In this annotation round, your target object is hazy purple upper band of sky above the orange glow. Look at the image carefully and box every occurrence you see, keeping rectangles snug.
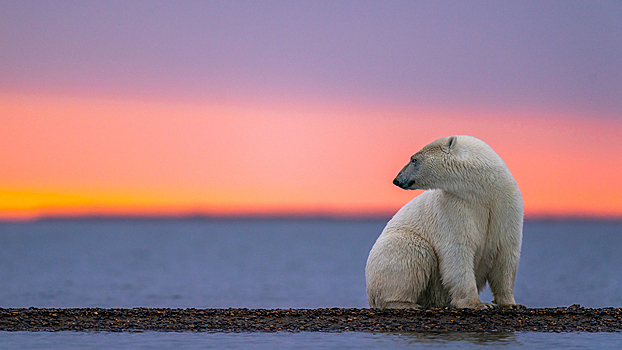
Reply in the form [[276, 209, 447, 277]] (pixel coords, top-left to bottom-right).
[[0, 0, 622, 118]]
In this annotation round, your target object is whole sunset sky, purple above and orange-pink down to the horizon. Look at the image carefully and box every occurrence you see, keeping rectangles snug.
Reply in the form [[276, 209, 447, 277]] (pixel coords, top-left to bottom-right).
[[0, 0, 622, 219]]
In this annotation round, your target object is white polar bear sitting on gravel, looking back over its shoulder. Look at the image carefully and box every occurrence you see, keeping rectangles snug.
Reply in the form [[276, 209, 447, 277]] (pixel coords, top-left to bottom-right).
[[365, 135, 524, 309]]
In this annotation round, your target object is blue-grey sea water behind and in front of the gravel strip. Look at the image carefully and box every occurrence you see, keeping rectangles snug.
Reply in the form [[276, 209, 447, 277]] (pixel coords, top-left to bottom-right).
[[0, 217, 622, 349]]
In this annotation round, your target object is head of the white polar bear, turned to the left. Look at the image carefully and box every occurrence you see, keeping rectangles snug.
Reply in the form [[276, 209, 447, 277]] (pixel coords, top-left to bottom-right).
[[393, 135, 504, 192]]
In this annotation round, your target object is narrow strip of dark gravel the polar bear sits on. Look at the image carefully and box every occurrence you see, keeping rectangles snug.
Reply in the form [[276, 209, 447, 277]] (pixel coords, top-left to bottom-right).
[[0, 305, 622, 333]]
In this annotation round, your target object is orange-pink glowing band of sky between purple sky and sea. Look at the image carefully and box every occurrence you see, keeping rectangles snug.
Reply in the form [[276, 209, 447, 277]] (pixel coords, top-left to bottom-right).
[[0, 93, 622, 219]]
